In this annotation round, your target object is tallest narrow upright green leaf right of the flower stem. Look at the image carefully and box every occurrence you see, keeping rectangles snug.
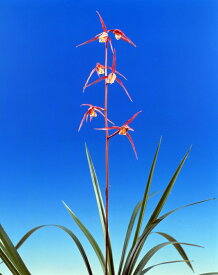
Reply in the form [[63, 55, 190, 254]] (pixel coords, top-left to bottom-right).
[[132, 138, 162, 246]]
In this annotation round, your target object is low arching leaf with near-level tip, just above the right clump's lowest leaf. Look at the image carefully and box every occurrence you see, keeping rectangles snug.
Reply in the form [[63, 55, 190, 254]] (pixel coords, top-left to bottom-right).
[[133, 242, 201, 275]]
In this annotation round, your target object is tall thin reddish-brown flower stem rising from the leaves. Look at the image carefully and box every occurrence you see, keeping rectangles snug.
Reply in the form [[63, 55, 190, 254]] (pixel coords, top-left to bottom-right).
[[104, 43, 109, 275]]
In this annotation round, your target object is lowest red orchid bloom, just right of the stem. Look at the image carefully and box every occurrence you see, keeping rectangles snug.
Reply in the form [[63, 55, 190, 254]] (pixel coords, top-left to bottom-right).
[[96, 111, 142, 159]]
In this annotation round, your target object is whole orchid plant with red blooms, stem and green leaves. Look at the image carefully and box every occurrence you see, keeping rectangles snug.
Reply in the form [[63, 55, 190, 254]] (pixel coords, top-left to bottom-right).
[[0, 11, 218, 275]]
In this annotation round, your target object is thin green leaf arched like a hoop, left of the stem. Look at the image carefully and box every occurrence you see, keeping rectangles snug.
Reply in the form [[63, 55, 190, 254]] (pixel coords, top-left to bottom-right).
[[5, 224, 93, 275]]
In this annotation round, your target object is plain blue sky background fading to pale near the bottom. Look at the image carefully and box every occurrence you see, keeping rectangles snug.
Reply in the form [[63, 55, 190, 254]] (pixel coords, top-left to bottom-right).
[[0, 0, 218, 275]]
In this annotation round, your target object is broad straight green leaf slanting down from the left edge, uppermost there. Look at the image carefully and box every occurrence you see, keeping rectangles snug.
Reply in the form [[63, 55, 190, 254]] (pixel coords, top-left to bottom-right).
[[0, 225, 30, 275]]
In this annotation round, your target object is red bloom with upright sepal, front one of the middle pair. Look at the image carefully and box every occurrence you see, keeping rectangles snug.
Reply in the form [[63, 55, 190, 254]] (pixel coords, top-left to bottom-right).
[[83, 50, 132, 101]]
